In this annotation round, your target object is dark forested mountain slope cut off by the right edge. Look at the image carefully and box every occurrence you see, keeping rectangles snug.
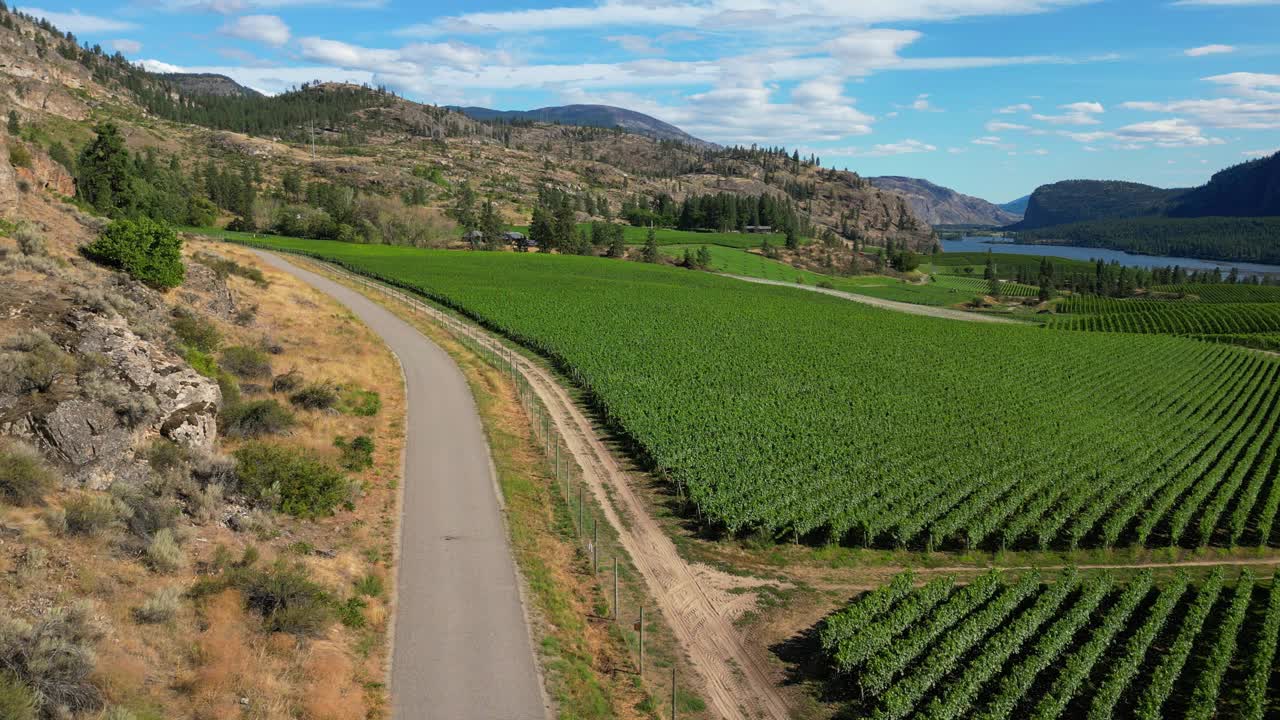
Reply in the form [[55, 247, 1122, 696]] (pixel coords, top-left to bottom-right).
[[1169, 152, 1280, 218]]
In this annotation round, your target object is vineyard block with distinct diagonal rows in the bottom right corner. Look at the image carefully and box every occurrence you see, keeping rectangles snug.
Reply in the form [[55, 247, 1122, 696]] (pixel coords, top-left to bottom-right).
[[819, 568, 1280, 720]]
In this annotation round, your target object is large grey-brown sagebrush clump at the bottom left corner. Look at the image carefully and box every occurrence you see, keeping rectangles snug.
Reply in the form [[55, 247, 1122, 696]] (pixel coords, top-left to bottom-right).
[[0, 603, 102, 717]]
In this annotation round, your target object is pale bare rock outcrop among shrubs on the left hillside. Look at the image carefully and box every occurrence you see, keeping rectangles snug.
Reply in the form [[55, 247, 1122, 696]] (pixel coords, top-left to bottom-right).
[[73, 314, 223, 450]]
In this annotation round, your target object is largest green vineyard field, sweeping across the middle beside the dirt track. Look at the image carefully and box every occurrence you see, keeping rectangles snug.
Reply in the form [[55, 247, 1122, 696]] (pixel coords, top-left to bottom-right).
[[227, 233, 1280, 547]]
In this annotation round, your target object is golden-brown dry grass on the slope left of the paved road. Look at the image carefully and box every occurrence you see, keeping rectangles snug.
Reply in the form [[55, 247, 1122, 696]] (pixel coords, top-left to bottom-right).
[[0, 239, 404, 720]]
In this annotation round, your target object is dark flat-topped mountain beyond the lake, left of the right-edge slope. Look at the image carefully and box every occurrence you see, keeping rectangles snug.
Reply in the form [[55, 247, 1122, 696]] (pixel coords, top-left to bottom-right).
[[1014, 181, 1188, 231]]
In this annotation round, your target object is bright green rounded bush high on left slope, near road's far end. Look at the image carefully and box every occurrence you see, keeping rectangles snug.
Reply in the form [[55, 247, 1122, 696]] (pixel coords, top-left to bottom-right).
[[84, 218, 187, 290]]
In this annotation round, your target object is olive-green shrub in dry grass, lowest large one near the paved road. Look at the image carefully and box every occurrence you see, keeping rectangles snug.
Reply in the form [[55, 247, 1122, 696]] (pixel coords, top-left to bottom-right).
[[238, 561, 333, 635]]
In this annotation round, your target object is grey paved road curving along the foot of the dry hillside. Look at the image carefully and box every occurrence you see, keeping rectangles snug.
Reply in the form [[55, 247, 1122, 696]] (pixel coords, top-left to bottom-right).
[[259, 252, 550, 720]]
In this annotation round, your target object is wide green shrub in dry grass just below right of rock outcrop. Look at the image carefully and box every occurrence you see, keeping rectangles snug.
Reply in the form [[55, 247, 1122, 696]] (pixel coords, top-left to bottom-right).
[[236, 442, 351, 518]]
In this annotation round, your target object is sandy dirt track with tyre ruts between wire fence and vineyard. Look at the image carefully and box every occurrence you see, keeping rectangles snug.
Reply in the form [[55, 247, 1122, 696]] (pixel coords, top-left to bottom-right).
[[290, 257, 791, 720]]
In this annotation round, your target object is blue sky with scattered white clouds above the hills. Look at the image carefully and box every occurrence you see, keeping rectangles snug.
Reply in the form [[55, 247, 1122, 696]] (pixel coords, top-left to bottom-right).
[[19, 0, 1280, 201]]
